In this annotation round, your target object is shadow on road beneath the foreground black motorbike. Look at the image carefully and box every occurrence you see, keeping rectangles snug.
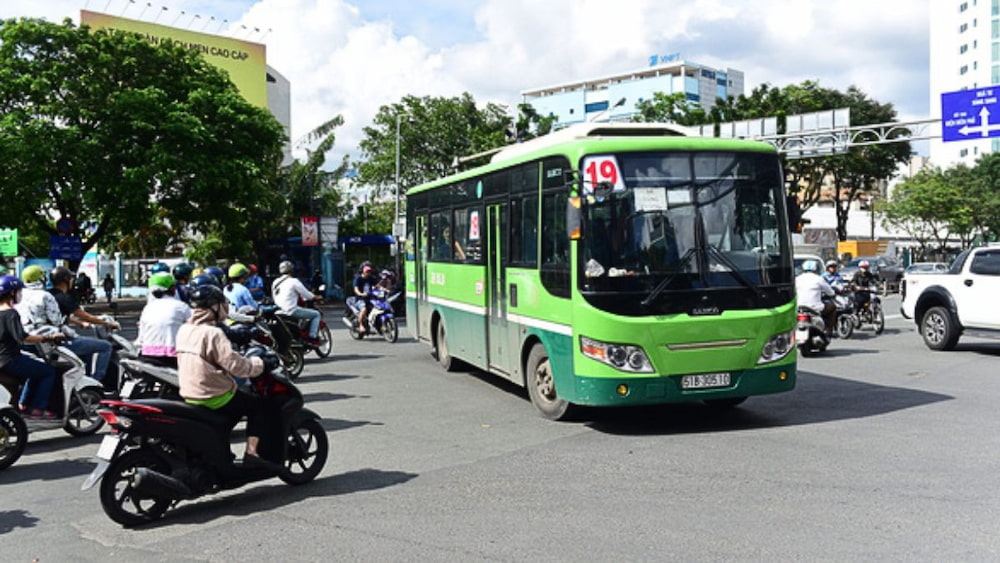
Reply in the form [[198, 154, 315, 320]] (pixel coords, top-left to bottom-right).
[[136, 468, 418, 530]]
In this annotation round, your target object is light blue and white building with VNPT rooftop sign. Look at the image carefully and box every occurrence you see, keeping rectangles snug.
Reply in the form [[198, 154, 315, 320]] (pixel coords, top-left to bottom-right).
[[521, 54, 743, 127]]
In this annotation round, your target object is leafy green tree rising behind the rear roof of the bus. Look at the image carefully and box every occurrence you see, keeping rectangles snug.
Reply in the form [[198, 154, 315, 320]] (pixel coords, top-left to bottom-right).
[[358, 92, 511, 203]]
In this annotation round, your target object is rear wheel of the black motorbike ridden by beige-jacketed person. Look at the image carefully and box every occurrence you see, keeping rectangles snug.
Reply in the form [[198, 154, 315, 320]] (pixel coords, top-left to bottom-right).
[[100, 450, 171, 527]]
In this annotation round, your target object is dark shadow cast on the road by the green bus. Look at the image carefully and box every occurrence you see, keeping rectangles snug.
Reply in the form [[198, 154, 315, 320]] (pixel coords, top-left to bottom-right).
[[584, 371, 954, 435]]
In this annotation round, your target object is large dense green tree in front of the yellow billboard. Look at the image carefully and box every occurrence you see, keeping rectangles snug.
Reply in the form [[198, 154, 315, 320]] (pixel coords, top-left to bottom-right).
[[0, 15, 283, 266]]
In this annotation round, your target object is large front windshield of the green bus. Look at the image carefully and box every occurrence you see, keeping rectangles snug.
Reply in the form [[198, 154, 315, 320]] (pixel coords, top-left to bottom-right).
[[579, 151, 793, 308]]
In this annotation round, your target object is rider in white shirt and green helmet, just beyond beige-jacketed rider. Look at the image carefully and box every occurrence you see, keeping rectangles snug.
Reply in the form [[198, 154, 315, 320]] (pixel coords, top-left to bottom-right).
[[136, 272, 191, 368]]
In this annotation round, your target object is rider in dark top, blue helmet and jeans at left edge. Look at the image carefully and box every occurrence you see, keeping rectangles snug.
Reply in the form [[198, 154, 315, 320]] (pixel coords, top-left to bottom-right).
[[0, 275, 62, 419]]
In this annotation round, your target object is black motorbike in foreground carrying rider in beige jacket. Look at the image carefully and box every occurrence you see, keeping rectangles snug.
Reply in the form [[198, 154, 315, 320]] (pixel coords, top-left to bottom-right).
[[82, 352, 329, 527]]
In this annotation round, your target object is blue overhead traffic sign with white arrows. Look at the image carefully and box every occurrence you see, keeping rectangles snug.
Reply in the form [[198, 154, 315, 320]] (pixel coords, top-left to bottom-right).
[[941, 86, 1000, 142]]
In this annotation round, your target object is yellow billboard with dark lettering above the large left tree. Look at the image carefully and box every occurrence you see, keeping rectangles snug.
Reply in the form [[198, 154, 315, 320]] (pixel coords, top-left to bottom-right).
[[80, 10, 267, 109]]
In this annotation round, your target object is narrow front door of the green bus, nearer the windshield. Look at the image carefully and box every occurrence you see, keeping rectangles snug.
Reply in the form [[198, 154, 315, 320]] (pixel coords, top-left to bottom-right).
[[486, 202, 510, 374]]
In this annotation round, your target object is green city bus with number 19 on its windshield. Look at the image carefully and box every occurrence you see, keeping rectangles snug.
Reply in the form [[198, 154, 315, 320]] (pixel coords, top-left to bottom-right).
[[406, 123, 796, 419]]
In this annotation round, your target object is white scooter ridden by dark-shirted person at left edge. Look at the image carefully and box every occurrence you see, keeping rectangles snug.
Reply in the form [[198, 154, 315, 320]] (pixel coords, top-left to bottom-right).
[[0, 326, 104, 436]]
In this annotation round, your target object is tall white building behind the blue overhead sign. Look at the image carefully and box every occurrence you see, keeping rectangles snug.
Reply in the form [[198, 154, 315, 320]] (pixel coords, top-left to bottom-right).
[[930, 0, 1000, 168]]
